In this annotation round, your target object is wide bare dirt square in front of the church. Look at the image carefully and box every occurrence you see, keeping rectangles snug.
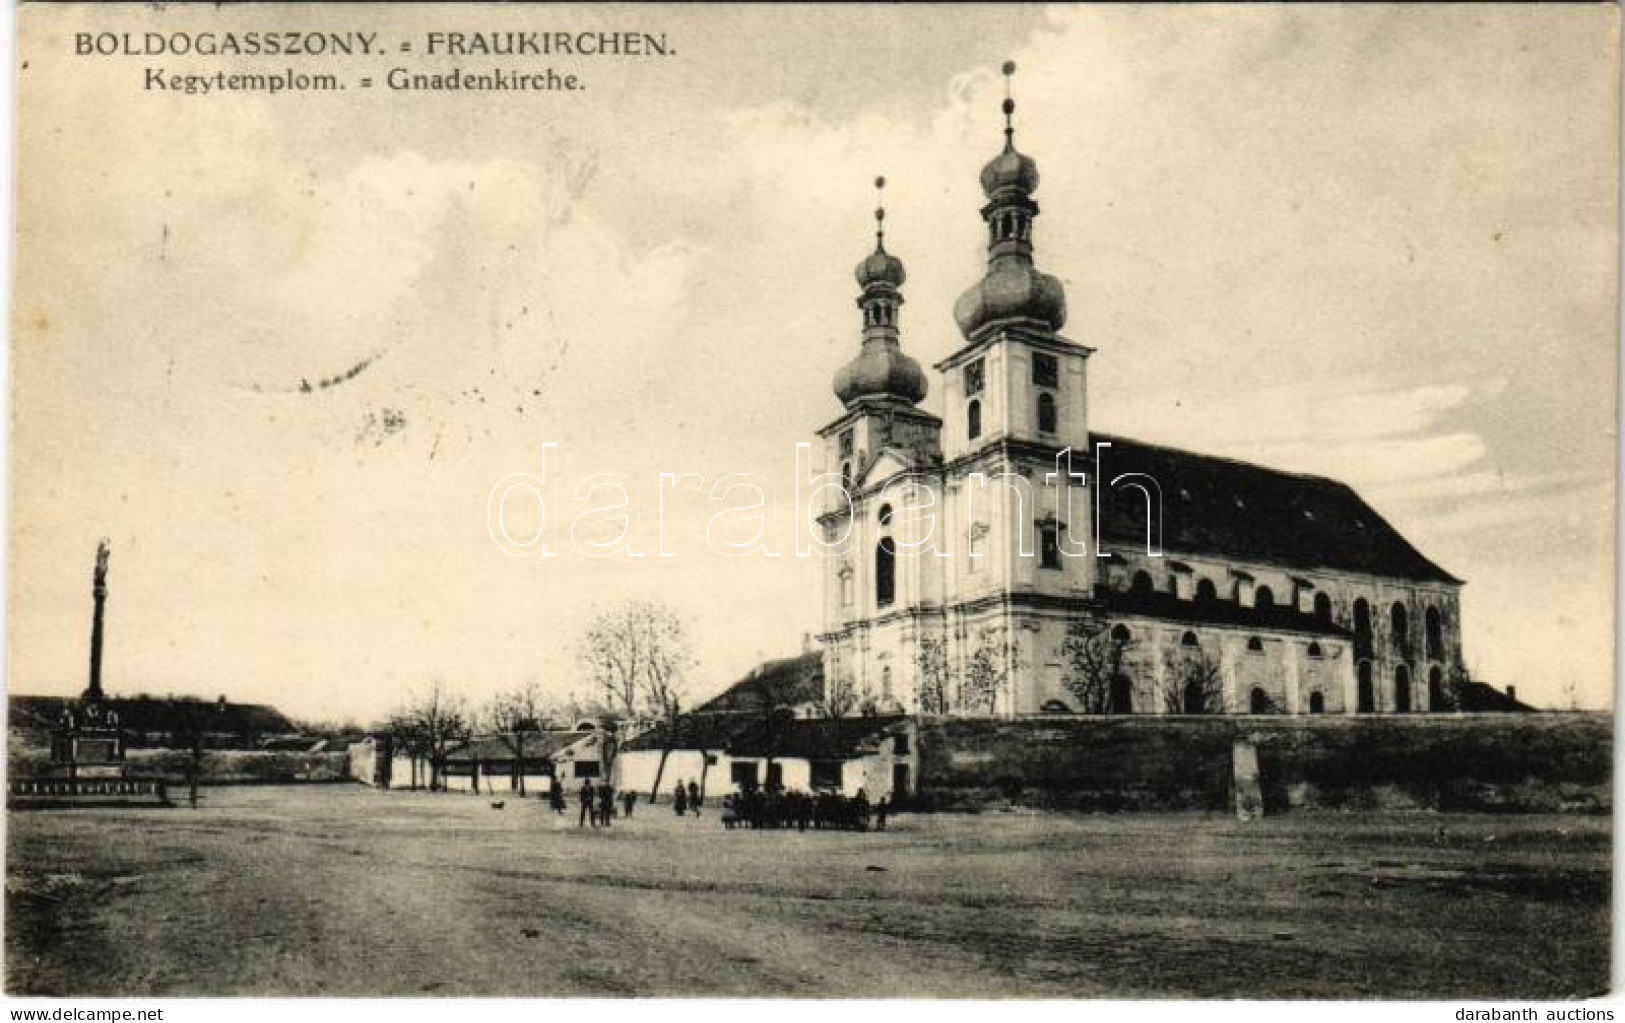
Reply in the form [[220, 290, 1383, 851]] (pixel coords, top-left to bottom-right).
[[5, 786, 1610, 999]]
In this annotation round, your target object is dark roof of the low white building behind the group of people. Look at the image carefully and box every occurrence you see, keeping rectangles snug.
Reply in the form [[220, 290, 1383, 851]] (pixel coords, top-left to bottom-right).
[[622, 714, 904, 760]]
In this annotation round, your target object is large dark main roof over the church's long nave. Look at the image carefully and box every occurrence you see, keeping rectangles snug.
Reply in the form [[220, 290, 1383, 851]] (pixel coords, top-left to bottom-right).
[[1094, 434, 1459, 583]]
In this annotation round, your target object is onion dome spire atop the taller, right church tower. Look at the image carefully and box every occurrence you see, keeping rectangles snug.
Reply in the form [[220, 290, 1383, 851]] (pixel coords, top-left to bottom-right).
[[954, 62, 1066, 341]]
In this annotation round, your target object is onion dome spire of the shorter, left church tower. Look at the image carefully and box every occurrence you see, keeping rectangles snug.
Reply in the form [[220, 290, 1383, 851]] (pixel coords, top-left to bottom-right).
[[834, 177, 926, 409]]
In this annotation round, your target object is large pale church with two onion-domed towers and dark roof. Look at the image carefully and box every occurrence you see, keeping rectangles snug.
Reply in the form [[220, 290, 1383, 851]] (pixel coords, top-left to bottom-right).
[[819, 80, 1464, 714]]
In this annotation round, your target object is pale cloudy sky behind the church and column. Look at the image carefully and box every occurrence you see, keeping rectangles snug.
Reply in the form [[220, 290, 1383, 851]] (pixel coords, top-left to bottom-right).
[[10, 5, 1619, 721]]
